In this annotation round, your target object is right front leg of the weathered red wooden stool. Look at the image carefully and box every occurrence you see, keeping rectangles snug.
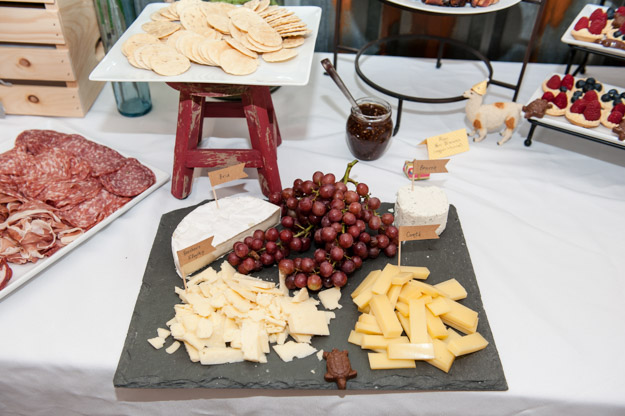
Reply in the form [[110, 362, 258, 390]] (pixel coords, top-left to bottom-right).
[[241, 86, 282, 195]]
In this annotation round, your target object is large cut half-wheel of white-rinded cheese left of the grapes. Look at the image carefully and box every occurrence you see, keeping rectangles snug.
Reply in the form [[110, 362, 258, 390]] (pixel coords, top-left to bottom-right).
[[171, 196, 280, 276]]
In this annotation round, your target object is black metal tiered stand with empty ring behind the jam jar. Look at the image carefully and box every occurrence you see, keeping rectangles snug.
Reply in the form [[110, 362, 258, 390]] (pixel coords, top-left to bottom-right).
[[334, 0, 546, 135]]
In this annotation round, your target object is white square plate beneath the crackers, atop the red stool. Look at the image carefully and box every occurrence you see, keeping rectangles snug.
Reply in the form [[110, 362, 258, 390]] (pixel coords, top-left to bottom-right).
[[89, 3, 321, 86]]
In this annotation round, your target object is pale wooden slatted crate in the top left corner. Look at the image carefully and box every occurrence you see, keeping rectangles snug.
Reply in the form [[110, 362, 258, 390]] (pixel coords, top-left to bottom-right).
[[0, 0, 104, 117]]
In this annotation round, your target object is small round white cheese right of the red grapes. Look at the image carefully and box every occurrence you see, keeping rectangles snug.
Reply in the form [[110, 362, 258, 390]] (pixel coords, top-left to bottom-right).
[[395, 185, 449, 235]]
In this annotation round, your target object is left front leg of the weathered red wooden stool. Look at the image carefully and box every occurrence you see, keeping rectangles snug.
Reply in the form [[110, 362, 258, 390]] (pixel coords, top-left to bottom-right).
[[171, 91, 204, 199]]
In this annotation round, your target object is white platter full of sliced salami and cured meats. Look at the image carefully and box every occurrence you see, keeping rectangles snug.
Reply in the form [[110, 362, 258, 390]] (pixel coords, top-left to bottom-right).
[[0, 130, 169, 299]]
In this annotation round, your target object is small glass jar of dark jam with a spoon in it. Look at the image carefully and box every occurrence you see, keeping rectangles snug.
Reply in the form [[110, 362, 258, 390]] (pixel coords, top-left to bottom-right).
[[346, 97, 393, 160]]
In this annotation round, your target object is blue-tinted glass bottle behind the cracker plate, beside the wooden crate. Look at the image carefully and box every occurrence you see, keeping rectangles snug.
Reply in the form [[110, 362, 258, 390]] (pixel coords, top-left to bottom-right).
[[93, 0, 152, 117]]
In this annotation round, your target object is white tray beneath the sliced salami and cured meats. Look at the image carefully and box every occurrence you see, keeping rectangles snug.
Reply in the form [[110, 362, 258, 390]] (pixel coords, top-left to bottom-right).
[[0, 137, 169, 300]]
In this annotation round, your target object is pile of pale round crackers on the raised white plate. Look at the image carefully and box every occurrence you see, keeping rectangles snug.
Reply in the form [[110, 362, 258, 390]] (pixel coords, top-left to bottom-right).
[[122, 0, 311, 76]]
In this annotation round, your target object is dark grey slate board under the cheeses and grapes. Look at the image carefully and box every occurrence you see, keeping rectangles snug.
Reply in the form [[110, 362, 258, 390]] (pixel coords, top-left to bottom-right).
[[113, 203, 508, 391]]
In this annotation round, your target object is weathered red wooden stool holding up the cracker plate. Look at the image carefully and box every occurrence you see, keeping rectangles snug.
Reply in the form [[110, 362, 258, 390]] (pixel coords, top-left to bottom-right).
[[167, 82, 282, 199]]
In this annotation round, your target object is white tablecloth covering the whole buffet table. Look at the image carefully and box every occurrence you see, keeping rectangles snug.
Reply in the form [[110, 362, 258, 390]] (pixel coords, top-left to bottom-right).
[[0, 54, 625, 415]]
